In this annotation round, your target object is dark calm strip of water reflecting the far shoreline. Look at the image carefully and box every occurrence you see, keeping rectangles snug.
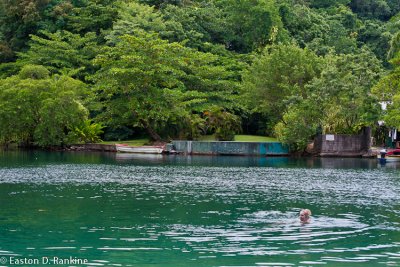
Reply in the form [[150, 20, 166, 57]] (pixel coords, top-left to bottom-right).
[[0, 150, 384, 169]]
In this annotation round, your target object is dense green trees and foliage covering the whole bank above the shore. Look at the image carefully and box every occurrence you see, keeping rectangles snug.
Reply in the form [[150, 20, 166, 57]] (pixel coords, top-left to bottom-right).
[[0, 0, 400, 150]]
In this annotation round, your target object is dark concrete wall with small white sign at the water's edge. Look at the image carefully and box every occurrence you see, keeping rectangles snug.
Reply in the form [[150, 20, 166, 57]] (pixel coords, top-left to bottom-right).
[[314, 128, 371, 157]]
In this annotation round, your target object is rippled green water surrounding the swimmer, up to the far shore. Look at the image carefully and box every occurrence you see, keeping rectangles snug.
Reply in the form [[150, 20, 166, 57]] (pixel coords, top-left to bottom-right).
[[0, 151, 400, 267]]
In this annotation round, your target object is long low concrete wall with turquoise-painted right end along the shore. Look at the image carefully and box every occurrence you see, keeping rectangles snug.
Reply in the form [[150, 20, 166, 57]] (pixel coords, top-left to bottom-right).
[[172, 141, 289, 156]]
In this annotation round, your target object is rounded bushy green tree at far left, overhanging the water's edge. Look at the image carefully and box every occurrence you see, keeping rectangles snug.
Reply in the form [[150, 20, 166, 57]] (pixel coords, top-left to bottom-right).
[[0, 65, 97, 147]]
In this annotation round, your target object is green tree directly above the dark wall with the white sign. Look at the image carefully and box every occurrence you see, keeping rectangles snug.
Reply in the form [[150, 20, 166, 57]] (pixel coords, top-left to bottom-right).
[[309, 49, 383, 134]]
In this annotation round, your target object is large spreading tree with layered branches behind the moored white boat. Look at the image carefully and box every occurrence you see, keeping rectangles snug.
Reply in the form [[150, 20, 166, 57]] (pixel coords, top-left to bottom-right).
[[94, 32, 242, 140]]
